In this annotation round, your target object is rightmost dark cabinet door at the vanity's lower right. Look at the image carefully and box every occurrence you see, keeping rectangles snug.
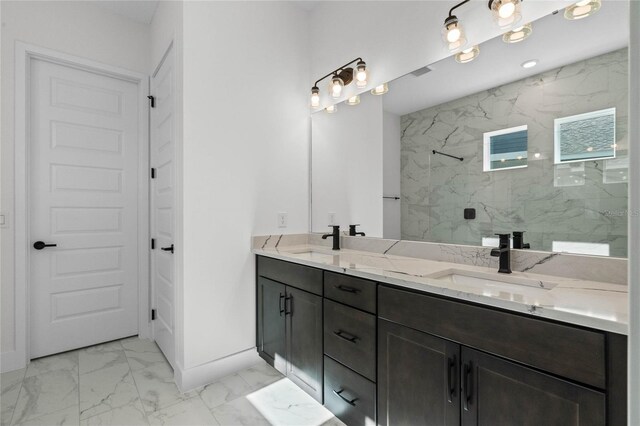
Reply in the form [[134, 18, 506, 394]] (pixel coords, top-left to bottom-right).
[[460, 347, 606, 426]]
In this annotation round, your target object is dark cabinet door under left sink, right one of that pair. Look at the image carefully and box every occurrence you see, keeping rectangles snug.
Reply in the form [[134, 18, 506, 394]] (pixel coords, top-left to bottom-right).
[[286, 287, 323, 403]]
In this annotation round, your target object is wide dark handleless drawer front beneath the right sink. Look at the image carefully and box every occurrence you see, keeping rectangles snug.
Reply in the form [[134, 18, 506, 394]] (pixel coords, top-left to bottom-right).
[[378, 286, 606, 389]]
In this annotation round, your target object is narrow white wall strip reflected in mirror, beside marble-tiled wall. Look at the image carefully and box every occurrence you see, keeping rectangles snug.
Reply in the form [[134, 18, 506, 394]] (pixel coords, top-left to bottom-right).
[[382, 111, 402, 240]]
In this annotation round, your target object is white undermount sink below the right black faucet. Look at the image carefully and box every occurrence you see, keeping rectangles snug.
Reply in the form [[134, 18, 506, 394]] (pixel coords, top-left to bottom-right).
[[429, 269, 558, 290]]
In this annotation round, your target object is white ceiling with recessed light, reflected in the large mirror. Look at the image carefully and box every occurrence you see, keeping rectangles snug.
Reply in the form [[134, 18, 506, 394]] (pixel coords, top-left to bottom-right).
[[384, 1, 629, 115]]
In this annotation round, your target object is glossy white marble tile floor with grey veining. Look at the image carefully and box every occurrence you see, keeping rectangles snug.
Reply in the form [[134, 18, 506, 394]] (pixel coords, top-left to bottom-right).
[[0, 337, 343, 426]]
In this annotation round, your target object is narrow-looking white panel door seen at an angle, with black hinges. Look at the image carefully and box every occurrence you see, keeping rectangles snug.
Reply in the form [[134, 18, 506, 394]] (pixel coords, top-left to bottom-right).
[[151, 45, 175, 366]]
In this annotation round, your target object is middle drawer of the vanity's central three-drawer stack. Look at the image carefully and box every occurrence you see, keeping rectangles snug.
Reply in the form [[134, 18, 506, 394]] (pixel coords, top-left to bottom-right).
[[324, 299, 376, 381]]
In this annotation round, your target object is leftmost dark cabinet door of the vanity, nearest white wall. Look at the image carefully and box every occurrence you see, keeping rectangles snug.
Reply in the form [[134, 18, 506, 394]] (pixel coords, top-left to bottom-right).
[[257, 277, 286, 374]]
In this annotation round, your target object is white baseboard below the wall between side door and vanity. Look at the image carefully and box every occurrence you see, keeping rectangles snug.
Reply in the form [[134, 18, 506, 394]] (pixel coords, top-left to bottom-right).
[[174, 348, 261, 392]]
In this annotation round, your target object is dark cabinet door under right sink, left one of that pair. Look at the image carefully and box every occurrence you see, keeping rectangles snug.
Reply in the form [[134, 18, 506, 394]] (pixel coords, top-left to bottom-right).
[[378, 320, 460, 426]]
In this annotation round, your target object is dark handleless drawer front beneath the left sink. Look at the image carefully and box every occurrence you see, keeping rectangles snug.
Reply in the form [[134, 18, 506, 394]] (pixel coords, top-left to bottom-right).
[[258, 256, 322, 296]]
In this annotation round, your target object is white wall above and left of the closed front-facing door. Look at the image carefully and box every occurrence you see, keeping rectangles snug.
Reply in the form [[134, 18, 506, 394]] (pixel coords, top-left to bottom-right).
[[0, 1, 149, 370]]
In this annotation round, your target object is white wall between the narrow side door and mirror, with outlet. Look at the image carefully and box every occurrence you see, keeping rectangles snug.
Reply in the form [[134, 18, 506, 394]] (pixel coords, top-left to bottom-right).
[[182, 2, 311, 376]]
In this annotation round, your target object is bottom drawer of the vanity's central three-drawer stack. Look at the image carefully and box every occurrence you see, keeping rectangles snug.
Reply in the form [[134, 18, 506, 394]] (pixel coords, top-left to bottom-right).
[[324, 356, 376, 426]]
